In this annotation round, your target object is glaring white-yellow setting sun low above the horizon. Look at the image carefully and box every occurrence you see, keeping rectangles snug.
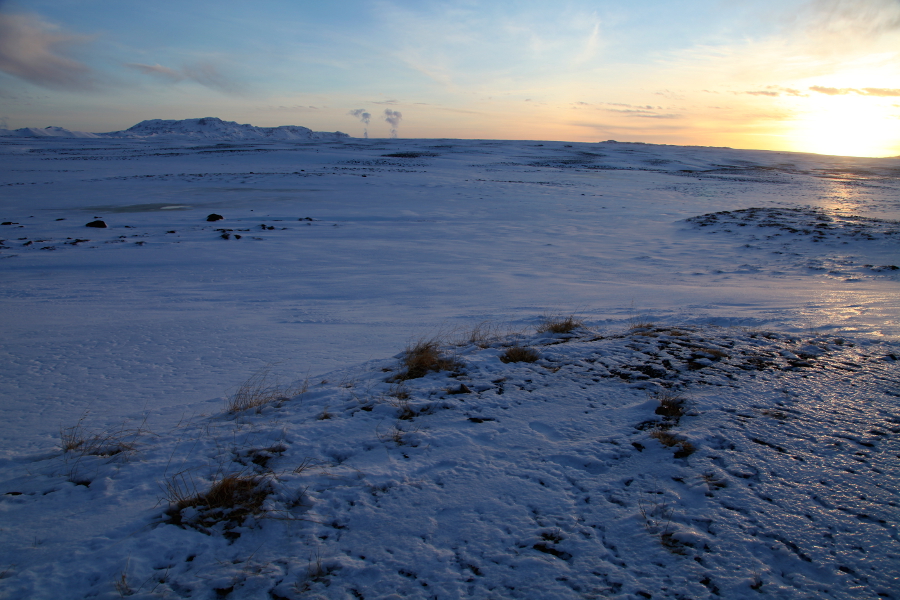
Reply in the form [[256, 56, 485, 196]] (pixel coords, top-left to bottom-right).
[[787, 94, 900, 157]]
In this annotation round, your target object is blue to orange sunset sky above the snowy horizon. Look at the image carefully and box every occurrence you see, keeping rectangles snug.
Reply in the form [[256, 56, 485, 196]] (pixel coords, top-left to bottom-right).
[[0, 0, 900, 156]]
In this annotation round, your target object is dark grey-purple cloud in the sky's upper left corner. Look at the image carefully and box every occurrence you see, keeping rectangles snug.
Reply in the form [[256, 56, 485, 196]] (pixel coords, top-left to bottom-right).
[[0, 14, 97, 91]]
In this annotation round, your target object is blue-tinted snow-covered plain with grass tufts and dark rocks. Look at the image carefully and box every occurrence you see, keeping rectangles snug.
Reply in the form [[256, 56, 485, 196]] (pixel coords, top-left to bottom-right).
[[0, 134, 900, 599]]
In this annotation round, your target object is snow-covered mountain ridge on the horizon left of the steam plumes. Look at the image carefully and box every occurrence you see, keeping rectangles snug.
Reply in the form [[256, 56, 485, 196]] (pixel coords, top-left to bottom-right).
[[0, 117, 350, 141]]
